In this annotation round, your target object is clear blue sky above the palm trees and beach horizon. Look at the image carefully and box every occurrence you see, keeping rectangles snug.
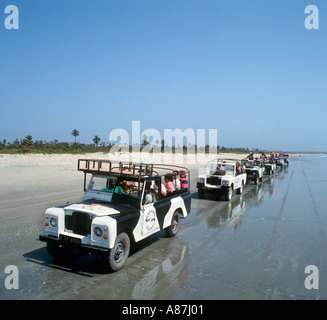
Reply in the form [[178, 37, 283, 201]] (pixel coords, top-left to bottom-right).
[[0, 0, 327, 151]]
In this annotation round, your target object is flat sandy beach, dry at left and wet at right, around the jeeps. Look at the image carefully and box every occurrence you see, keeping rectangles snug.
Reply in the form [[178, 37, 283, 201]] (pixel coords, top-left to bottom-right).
[[0, 155, 327, 300]]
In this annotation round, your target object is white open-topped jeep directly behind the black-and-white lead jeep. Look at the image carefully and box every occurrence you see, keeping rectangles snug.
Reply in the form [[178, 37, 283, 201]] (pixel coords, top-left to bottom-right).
[[197, 160, 246, 201]]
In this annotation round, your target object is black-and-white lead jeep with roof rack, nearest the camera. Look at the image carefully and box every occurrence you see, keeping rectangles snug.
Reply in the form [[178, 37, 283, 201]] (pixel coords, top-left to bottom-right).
[[39, 159, 191, 272]]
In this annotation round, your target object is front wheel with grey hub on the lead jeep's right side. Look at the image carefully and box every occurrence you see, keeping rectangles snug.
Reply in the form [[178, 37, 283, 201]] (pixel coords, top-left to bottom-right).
[[104, 232, 131, 272]]
